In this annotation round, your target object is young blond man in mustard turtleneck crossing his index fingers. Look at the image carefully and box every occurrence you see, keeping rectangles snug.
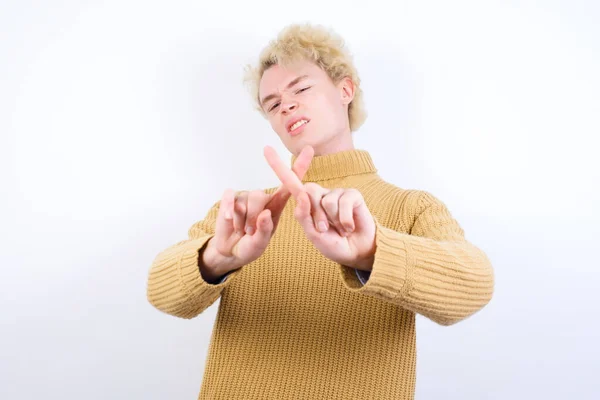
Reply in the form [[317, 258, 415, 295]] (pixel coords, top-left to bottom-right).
[[147, 25, 494, 399]]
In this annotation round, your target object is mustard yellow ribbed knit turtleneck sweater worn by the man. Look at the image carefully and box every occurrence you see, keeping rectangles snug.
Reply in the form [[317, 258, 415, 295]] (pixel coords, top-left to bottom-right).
[[147, 150, 494, 400]]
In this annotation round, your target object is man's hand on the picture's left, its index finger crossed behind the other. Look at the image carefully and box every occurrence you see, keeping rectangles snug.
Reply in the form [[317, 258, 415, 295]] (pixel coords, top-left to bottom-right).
[[199, 146, 314, 280]]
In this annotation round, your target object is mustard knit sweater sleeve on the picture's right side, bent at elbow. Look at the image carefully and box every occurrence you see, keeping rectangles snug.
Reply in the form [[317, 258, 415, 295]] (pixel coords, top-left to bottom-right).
[[340, 192, 494, 325]]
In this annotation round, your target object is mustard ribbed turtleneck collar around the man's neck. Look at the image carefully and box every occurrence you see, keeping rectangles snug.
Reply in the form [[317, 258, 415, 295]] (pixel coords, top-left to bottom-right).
[[290, 149, 377, 182]]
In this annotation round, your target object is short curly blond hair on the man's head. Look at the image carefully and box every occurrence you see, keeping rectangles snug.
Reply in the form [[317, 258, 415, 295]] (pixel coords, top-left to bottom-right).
[[244, 23, 367, 131]]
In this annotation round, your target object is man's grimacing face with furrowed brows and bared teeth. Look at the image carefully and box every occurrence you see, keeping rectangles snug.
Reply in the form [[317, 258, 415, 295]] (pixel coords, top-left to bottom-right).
[[259, 61, 354, 155]]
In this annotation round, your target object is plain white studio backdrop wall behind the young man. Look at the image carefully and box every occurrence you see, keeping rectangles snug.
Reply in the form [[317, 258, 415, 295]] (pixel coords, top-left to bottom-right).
[[0, 0, 600, 400]]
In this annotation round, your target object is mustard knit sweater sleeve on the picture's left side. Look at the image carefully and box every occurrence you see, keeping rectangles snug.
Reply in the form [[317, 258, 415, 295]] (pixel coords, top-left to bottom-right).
[[146, 202, 242, 319]]
